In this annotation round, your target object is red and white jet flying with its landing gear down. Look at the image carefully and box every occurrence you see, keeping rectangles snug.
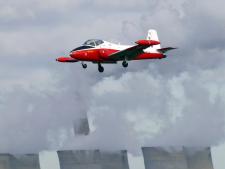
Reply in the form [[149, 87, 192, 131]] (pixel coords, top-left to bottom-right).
[[56, 30, 176, 72]]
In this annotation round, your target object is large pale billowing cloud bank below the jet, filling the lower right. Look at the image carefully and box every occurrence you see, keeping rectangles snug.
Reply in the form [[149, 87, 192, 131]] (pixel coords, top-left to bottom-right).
[[51, 60, 225, 154]]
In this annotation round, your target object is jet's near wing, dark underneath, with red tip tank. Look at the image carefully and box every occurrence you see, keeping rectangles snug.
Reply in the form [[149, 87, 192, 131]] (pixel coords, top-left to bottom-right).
[[109, 40, 160, 61]]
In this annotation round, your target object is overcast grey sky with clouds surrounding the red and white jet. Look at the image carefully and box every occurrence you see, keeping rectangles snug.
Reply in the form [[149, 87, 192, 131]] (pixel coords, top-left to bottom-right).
[[0, 0, 225, 168]]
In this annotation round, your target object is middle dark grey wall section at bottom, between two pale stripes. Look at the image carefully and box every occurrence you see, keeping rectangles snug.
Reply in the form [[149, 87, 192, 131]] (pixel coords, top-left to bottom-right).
[[58, 150, 129, 169]]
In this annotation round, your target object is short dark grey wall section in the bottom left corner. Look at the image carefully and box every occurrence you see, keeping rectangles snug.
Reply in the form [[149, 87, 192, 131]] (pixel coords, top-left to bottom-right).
[[0, 154, 40, 169]]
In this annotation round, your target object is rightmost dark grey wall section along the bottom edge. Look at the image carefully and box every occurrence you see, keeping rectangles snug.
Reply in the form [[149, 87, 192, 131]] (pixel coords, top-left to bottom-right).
[[142, 147, 213, 169]]
